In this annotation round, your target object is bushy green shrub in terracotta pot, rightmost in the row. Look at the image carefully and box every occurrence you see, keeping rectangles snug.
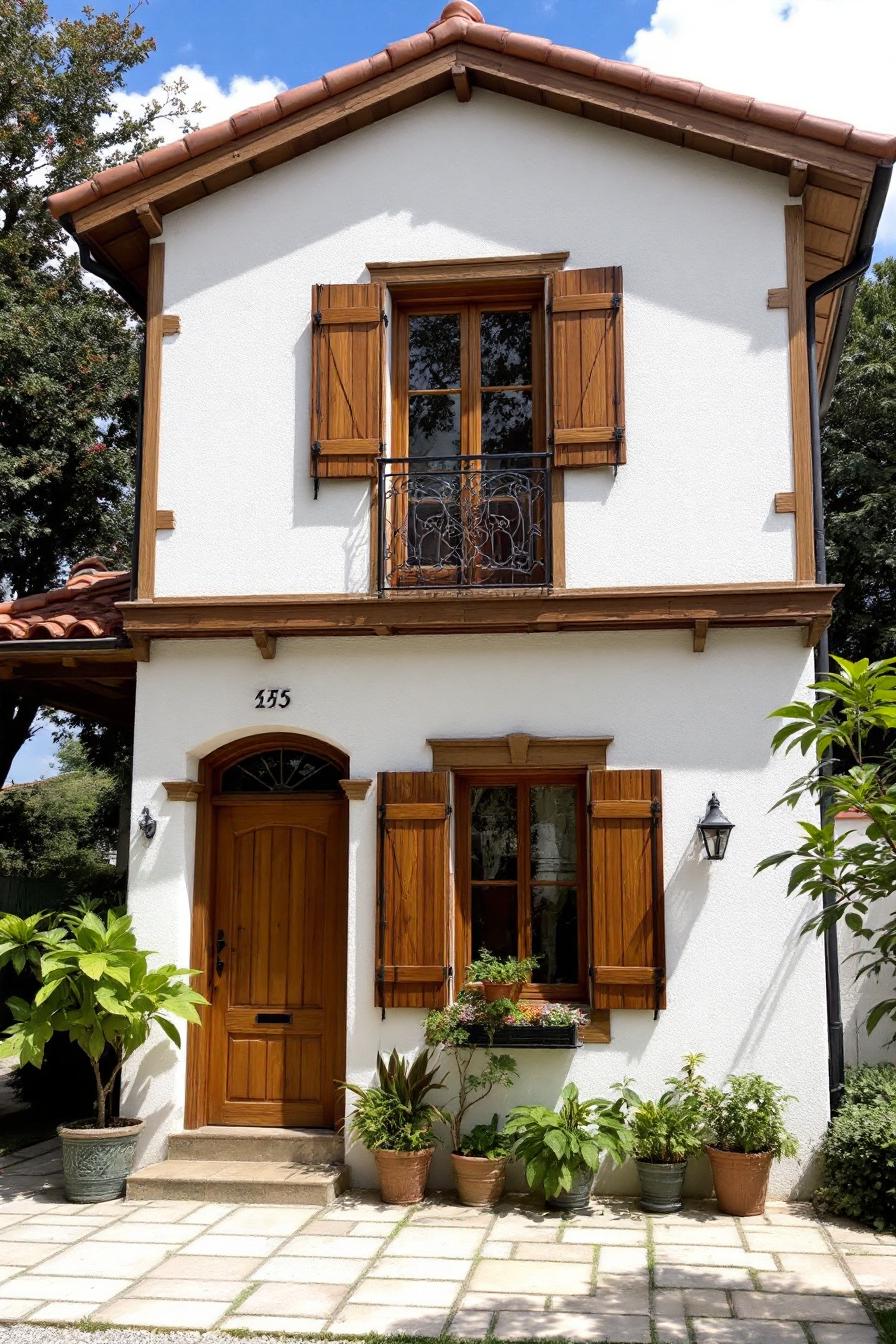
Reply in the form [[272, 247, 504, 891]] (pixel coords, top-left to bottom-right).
[[703, 1074, 797, 1218]]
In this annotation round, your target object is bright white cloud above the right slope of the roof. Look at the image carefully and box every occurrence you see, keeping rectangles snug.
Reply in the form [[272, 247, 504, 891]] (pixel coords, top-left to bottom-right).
[[626, 0, 896, 246]]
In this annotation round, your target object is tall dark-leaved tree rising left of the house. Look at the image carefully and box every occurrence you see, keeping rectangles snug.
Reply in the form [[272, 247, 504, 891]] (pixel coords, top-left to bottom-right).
[[0, 0, 196, 782]]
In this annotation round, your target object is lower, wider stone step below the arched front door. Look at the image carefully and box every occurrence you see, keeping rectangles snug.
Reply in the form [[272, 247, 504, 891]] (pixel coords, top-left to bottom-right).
[[126, 1159, 348, 1206]]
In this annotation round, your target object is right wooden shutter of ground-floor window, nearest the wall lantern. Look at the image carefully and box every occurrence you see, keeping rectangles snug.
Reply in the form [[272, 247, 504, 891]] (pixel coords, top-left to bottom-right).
[[591, 770, 666, 1013]]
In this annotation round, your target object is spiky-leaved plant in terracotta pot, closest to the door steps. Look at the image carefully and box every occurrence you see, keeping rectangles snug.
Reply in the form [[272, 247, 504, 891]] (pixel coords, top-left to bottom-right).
[[343, 1050, 445, 1204]]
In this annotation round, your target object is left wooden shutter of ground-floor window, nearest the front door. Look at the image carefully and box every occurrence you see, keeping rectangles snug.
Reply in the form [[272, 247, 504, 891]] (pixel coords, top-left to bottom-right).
[[376, 770, 450, 1009]]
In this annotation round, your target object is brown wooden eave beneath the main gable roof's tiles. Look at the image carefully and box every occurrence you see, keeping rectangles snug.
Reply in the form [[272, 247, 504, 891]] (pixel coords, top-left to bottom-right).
[[73, 42, 879, 372]]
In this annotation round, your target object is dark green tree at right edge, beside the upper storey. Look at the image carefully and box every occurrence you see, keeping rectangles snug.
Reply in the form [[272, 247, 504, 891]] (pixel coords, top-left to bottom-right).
[[822, 257, 896, 659]]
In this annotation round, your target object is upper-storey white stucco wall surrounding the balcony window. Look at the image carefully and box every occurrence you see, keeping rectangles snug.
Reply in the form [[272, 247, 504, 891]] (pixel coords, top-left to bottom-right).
[[156, 90, 794, 595]]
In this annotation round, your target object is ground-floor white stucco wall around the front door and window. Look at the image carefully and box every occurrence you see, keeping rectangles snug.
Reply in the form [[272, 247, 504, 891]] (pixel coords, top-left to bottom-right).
[[124, 629, 827, 1195]]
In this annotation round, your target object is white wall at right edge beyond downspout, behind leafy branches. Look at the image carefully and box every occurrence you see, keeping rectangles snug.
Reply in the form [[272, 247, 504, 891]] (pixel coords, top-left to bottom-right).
[[836, 816, 896, 1064]]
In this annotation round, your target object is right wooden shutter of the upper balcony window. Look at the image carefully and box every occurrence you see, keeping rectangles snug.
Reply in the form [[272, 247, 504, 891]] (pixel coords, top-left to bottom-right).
[[549, 266, 626, 466]]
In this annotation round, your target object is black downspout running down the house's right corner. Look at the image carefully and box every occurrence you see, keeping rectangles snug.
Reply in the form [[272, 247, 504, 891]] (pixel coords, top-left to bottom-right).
[[806, 165, 892, 1116]]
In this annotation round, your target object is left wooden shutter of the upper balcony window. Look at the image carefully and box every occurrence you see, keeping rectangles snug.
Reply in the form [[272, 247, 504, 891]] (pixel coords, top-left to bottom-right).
[[312, 285, 386, 482]]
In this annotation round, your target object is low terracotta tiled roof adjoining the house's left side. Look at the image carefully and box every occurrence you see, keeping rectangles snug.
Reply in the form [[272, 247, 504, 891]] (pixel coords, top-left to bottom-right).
[[0, 555, 130, 642]]
